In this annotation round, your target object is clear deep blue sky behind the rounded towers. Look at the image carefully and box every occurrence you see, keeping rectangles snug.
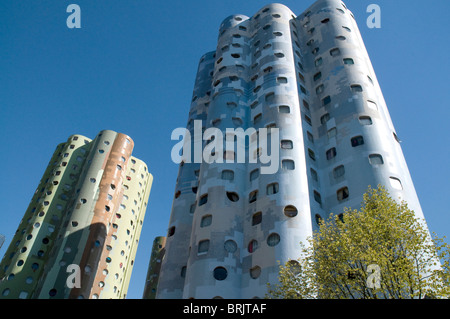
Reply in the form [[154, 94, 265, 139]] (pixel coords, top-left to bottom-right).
[[0, 0, 450, 298]]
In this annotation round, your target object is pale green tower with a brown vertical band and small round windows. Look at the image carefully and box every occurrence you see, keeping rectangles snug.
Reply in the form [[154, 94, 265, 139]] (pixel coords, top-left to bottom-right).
[[0, 130, 153, 299]]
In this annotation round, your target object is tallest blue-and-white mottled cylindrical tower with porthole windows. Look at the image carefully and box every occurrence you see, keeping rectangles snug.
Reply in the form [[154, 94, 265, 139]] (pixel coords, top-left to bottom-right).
[[157, 0, 423, 298]]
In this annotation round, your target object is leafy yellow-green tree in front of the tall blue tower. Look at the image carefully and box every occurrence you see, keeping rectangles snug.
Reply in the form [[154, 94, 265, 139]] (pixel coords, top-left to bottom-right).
[[266, 186, 450, 299]]
